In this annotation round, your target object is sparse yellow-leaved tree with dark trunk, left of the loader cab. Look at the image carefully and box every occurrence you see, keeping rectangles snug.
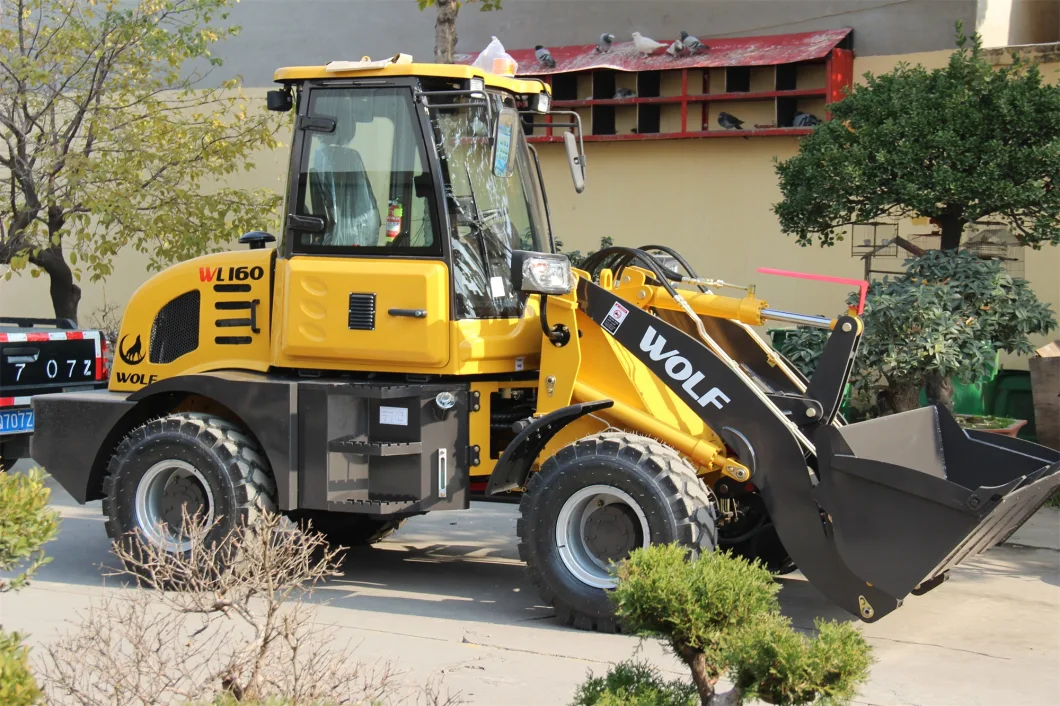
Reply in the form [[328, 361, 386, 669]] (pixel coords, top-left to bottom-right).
[[0, 0, 280, 319]]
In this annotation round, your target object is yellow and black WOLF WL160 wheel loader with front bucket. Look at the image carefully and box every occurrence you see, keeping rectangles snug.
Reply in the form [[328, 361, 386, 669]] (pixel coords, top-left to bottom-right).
[[32, 55, 1060, 631]]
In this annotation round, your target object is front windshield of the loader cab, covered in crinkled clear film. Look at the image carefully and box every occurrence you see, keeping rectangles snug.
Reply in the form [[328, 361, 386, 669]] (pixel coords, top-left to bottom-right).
[[436, 92, 550, 319]]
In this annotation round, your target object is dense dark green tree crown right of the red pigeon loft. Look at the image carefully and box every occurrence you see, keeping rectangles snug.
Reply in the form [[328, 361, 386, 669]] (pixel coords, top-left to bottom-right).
[[774, 23, 1060, 250]]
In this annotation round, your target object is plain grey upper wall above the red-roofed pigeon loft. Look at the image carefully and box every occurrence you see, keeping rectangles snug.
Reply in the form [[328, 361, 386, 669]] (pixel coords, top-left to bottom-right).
[[218, 0, 978, 86]]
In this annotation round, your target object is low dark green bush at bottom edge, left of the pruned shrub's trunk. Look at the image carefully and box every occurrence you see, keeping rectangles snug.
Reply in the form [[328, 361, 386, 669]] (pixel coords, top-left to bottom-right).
[[570, 660, 700, 706]]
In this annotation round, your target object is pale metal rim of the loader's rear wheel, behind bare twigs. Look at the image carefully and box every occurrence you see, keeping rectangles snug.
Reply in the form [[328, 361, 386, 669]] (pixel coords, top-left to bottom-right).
[[136, 459, 214, 552]]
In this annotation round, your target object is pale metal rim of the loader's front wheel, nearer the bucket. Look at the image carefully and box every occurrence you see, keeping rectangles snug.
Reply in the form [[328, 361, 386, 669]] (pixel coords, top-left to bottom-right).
[[555, 486, 651, 588]]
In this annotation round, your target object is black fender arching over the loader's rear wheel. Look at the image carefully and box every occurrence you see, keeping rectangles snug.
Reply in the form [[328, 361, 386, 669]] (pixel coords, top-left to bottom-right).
[[127, 370, 298, 510]]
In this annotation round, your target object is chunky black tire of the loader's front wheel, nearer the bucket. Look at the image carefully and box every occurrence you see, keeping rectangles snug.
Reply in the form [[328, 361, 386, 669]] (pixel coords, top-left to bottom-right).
[[516, 431, 718, 633]]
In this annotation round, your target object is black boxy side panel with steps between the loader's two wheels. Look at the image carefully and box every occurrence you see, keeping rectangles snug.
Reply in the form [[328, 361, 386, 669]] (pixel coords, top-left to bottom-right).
[[298, 382, 470, 515]]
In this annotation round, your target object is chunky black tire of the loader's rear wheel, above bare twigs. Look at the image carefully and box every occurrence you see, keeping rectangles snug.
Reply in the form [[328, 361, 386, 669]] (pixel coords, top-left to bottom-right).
[[103, 412, 277, 540]]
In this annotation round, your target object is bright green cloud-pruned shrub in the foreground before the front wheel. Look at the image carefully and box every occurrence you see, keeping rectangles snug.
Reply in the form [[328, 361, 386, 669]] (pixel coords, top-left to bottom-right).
[[575, 545, 871, 706]]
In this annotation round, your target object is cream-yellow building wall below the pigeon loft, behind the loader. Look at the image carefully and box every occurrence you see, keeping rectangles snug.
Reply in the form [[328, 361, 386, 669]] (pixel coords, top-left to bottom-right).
[[0, 51, 1060, 368]]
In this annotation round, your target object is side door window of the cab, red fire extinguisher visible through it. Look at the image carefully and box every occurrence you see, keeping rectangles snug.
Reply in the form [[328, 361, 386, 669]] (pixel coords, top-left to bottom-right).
[[293, 88, 441, 255]]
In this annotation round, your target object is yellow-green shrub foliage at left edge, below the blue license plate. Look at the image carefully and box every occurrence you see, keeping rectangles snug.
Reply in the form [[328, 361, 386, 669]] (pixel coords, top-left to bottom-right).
[[0, 469, 58, 706]]
